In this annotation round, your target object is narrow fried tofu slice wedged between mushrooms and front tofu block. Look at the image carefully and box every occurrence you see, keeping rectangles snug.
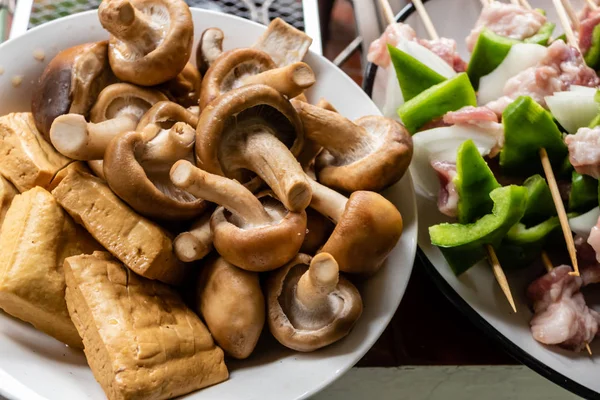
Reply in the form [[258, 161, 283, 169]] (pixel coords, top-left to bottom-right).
[[52, 168, 186, 284]]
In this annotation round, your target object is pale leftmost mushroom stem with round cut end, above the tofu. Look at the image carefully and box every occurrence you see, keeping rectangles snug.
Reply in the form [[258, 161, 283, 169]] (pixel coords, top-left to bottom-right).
[[50, 114, 137, 161]]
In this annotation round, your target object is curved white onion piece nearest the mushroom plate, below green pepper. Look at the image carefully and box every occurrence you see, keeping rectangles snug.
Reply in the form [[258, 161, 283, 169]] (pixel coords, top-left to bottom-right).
[[410, 125, 496, 199]]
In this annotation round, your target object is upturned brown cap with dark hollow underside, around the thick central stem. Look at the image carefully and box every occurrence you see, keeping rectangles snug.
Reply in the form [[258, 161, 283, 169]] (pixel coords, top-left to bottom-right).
[[196, 85, 304, 183]]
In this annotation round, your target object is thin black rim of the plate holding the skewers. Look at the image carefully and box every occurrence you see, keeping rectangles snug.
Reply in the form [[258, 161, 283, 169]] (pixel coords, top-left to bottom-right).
[[362, 0, 600, 399]]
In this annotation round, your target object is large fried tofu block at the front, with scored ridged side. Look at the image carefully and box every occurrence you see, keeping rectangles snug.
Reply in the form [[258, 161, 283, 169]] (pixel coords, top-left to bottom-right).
[[65, 252, 229, 400]]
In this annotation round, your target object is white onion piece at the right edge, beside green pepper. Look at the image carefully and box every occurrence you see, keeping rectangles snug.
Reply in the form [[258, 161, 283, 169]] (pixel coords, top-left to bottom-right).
[[544, 88, 600, 134]]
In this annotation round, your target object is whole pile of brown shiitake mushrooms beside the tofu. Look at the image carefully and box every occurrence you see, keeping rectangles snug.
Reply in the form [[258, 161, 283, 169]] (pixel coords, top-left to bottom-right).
[[23, 0, 412, 359]]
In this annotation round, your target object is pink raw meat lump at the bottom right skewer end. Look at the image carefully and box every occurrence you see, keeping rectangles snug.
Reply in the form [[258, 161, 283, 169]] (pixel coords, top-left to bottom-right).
[[527, 265, 600, 351]]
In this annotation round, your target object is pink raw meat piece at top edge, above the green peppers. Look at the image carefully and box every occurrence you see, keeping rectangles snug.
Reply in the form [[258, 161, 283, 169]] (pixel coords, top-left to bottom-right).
[[467, 1, 546, 51]]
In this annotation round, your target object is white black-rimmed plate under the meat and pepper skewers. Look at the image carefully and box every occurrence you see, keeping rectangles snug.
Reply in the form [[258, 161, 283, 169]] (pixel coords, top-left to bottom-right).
[[365, 0, 600, 398]]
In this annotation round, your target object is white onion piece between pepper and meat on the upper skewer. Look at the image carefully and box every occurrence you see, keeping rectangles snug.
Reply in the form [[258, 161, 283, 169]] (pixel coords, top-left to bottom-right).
[[477, 43, 548, 104]]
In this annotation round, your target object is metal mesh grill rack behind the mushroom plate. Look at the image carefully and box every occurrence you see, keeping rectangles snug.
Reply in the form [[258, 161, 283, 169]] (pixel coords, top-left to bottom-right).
[[29, 0, 305, 30]]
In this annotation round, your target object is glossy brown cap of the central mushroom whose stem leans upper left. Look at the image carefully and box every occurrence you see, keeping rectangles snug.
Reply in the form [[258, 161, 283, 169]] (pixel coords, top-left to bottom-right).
[[210, 192, 306, 272]]
